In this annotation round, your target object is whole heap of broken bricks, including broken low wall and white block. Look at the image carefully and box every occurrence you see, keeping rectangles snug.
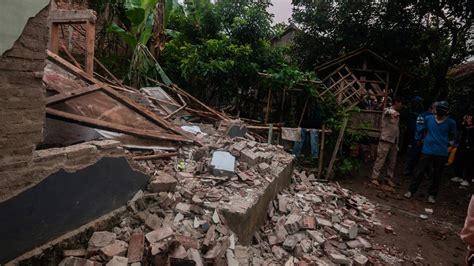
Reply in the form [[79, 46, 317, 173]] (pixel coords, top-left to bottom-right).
[[54, 128, 399, 265]]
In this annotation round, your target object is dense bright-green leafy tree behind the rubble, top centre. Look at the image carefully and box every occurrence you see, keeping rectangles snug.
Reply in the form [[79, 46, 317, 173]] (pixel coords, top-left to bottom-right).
[[160, 0, 306, 116]]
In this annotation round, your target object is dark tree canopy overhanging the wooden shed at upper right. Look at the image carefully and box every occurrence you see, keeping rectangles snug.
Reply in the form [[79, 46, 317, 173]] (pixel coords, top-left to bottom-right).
[[293, 0, 473, 98]]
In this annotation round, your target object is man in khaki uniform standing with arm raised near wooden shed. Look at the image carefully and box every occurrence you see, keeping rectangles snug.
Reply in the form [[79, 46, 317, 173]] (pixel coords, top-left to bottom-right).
[[370, 97, 402, 187]]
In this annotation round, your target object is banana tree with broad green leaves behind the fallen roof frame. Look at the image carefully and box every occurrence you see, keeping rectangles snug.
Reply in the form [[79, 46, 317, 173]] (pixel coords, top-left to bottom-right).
[[108, 0, 171, 86]]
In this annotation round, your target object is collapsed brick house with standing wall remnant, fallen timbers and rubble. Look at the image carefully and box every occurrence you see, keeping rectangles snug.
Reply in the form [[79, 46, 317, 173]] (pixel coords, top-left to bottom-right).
[[0, 3, 414, 265]]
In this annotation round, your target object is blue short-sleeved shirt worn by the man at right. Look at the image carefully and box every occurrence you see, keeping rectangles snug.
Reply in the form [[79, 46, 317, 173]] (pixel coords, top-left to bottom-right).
[[422, 115, 456, 156]]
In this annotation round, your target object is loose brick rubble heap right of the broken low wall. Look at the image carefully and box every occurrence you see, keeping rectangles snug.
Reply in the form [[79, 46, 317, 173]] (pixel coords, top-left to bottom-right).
[[251, 171, 403, 265]]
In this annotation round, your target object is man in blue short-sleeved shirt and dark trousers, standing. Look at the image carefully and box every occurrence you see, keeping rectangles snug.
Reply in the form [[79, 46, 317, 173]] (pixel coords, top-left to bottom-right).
[[404, 101, 456, 203]]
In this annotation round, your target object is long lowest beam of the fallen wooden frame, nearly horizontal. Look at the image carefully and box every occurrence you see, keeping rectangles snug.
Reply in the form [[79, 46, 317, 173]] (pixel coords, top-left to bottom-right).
[[46, 107, 191, 142]]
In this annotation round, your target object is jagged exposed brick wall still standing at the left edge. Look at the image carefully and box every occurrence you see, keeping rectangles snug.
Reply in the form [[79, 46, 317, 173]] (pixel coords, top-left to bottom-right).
[[0, 7, 49, 195]]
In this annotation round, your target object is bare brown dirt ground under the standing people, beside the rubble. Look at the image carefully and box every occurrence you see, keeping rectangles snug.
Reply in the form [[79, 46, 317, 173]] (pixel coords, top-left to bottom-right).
[[337, 154, 474, 265]]
